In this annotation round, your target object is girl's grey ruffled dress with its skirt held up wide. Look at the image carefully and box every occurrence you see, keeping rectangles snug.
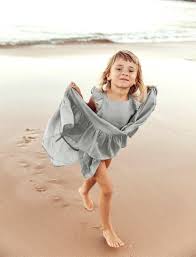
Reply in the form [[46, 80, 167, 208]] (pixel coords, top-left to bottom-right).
[[42, 86, 157, 179]]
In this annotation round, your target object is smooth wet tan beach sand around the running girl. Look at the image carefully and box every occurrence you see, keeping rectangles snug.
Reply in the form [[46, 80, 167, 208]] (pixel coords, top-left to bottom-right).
[[0, 42, 196, 257]]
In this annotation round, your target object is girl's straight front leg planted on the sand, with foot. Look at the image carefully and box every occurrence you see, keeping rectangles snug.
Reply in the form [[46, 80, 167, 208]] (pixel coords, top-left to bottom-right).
[[95, 161, 124, 247]]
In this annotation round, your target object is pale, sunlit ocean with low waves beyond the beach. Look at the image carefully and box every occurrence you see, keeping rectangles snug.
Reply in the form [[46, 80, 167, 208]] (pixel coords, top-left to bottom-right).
[[0, 0, 196, 47]]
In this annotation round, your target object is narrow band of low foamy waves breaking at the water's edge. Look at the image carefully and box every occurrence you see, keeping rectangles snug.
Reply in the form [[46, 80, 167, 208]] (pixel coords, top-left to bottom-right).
[[0, 31, 196, 48]]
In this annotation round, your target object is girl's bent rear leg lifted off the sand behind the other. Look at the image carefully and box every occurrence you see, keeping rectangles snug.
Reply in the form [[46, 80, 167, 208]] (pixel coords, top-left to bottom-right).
[[78, 159, 112, 211]]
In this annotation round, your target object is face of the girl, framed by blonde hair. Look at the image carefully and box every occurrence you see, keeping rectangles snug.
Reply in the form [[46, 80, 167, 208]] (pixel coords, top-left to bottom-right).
[[107, 58, 137, 88]]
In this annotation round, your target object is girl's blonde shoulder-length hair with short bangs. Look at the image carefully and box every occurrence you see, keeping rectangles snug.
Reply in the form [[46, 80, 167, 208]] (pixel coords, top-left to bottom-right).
[[99, 50, 144, 95]]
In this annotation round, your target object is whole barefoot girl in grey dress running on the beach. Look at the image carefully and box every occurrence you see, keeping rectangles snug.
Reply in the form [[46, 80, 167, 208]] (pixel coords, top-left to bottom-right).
[[42, 51, 157, 247]]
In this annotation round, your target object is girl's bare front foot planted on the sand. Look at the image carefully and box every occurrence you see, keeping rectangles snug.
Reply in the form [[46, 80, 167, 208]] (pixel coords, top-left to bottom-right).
[[101, 227, 125, 248]]
